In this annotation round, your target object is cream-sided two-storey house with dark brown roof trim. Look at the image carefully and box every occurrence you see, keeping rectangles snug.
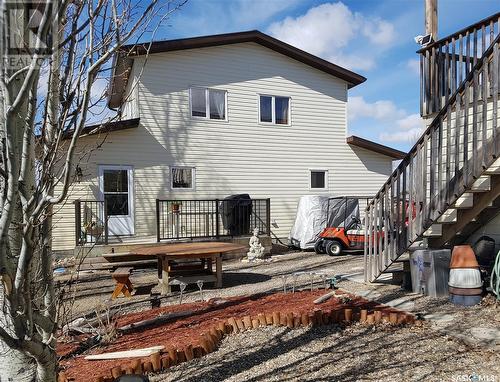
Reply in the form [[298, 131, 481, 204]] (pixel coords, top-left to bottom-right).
[[53, 31, 404, 254]]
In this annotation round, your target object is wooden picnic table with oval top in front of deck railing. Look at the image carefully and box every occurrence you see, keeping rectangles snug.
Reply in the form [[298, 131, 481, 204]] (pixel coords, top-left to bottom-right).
[[134, 241, 245, 295]]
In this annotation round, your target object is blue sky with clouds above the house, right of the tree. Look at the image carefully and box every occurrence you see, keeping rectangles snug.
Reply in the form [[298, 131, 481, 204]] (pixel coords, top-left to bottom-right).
[[155, 0, 500, 150]]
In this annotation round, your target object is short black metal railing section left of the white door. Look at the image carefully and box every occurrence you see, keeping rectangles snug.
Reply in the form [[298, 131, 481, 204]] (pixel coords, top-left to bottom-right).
[[74, 199, 108, 246]]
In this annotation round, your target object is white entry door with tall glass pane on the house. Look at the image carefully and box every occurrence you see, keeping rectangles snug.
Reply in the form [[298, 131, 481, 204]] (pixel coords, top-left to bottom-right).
[[99, 166, 134, 236]]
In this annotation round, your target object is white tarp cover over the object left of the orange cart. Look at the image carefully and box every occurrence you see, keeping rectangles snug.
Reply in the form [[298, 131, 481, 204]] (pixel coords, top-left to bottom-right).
[[289, 195, 329, 249]]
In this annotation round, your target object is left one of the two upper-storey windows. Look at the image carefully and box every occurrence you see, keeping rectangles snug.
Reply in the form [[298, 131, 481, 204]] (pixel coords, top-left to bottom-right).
[[189, 88, 227, 120]]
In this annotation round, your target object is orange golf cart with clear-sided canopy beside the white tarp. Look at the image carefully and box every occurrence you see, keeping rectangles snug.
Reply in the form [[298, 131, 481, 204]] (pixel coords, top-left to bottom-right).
[[314, 196, 365, 256]]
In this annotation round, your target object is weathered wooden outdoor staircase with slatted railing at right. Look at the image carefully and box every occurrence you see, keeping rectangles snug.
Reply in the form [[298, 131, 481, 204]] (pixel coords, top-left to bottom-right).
[[364, 13, 500, 281]]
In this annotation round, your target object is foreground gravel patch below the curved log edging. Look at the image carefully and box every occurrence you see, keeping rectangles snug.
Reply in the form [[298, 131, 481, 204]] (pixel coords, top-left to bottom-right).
[[150, 325, 500, 382]]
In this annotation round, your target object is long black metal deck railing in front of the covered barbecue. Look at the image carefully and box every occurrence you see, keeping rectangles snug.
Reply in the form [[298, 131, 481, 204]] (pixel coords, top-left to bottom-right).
[[156, 199, 271, 241]]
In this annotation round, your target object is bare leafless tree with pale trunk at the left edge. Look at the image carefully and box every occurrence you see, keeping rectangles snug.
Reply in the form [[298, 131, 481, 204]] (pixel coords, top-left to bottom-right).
[[0, 0, 184, 381]]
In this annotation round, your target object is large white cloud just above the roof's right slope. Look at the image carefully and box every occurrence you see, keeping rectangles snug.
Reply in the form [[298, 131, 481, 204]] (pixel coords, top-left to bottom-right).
[[268, 2, 395, 70]]
